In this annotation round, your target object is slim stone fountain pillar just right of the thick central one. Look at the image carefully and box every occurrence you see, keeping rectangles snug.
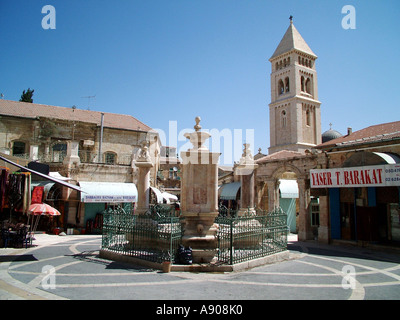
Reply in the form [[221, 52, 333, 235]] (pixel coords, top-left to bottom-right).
[[236, 143, 258, 216]]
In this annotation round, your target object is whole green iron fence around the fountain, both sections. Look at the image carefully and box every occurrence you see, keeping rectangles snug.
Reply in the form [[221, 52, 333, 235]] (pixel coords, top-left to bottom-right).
[[102, 207, 288, 265]]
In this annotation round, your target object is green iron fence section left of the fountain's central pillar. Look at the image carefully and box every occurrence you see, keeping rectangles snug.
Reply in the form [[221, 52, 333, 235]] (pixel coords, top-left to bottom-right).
[[102, 208, 182, 263]]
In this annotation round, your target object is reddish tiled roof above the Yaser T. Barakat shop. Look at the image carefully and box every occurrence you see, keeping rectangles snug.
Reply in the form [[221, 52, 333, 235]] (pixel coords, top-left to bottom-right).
[[316, 121, 400, 149]]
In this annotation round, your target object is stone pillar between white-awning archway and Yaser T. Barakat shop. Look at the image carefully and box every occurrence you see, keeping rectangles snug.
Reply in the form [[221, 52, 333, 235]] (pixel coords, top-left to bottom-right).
[[297, 178, 313, 241]]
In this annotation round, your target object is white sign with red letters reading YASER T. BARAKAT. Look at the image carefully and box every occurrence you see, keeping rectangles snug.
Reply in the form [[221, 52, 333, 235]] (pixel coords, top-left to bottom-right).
[[310, 164, 400, 188]]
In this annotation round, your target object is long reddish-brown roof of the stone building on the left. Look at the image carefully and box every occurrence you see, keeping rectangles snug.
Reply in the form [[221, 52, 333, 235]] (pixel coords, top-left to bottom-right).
[[0, 100, 151, 132]]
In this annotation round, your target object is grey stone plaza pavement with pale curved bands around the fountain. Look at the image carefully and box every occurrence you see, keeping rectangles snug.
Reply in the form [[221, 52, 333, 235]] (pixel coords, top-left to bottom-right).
[[0, 234, 400, 301]]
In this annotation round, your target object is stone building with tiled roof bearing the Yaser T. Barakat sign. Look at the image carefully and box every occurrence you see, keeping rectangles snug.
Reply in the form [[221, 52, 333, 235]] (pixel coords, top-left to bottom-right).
[[310, 121, 400, 245]]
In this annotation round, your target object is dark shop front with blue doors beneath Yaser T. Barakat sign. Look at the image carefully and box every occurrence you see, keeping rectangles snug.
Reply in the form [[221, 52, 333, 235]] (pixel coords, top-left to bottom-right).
[[310, 164, 400, 244]]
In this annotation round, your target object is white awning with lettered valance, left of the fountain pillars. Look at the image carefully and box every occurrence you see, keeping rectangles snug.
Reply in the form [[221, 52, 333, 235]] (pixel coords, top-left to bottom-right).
[[79, 181, 137, 203]]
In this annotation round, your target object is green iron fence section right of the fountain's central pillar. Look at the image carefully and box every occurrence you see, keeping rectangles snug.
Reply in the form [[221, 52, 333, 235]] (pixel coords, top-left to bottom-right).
[[215, 208, 288, 265]]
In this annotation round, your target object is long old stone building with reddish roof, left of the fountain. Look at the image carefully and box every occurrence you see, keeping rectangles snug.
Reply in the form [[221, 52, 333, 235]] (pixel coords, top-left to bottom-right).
[[0, 100, 160, 228]]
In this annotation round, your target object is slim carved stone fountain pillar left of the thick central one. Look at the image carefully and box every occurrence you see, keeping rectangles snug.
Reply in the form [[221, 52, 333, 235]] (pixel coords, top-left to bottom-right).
[[135, 141, 153, 215]]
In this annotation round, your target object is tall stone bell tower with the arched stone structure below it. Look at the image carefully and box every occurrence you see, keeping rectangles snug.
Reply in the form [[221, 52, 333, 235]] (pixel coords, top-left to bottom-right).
[[256, 20, 322, 240]]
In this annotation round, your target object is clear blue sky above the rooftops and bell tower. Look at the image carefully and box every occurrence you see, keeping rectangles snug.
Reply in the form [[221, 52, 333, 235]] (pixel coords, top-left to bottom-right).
[[0, 0, 400, 164]]
